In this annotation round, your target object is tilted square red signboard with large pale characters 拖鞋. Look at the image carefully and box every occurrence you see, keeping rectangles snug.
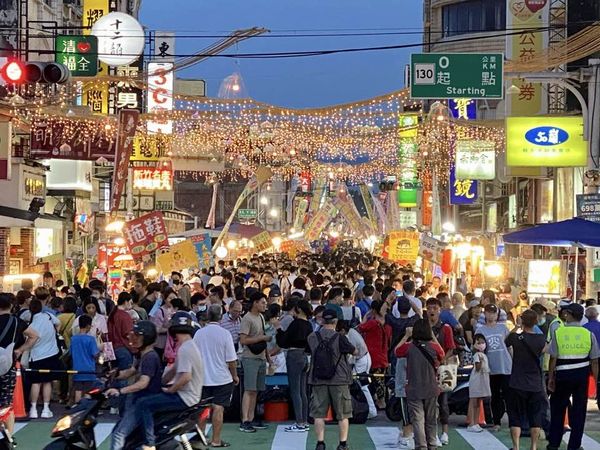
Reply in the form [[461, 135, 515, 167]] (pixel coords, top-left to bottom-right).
[[123, 212, 169, 261]]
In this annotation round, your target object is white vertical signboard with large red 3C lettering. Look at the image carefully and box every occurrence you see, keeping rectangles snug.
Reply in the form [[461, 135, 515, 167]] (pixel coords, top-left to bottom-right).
[[147, 62, 174, 134]]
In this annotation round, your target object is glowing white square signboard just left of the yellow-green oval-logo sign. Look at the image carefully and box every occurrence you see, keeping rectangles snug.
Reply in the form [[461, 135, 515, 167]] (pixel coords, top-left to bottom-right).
[[455, 140, 496, 180]]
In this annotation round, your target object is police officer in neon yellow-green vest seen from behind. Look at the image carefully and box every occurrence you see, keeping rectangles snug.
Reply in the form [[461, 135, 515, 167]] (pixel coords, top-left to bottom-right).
[[547, 303, 600, 450]]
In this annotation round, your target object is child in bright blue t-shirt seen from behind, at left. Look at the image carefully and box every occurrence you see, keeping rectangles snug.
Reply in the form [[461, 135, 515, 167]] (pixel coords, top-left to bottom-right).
[[71, 314, 100, 403]]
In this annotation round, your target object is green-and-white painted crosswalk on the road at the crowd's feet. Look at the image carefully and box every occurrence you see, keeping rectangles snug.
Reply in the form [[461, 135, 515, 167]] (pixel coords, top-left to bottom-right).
[[9, 421, 600, 450]]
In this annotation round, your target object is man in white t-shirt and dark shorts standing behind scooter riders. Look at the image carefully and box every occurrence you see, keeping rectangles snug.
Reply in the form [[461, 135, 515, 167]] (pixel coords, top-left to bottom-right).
[[194, 305, 240, 447]]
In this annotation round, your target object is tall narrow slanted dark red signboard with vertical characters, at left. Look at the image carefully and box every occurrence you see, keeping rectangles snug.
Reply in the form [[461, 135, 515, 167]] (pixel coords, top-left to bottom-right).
[[110, 109, 140, 213]]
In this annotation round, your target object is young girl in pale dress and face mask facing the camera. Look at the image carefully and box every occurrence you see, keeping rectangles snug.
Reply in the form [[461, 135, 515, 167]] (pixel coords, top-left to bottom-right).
[[467, 334, 492, 433]]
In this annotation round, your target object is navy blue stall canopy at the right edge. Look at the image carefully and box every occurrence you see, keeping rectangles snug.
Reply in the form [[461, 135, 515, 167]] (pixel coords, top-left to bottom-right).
[[504, 218, 600, 247]]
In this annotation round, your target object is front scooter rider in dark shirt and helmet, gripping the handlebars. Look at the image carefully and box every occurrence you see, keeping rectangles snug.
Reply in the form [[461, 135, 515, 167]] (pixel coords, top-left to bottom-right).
[[105, 320, 162, 450]]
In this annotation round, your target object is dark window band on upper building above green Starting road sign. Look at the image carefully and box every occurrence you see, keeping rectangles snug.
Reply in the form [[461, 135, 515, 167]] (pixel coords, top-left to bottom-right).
[[442, 0, 506, 37]]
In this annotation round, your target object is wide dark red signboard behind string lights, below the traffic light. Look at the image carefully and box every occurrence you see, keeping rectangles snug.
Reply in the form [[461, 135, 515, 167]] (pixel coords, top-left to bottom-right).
[[31, 118, 116, 161]]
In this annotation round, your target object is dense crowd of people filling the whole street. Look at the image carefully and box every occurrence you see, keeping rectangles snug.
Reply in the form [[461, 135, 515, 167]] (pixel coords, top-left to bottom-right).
[[0, 247, 600, 450]]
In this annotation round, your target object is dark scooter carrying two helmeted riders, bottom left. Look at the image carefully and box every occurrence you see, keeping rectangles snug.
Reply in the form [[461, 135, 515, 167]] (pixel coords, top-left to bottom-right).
[[43, 389, 210, 450]]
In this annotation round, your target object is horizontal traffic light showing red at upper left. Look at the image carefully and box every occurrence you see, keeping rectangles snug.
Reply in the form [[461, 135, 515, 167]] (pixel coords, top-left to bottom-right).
[[0, 59, 71, 84]]
